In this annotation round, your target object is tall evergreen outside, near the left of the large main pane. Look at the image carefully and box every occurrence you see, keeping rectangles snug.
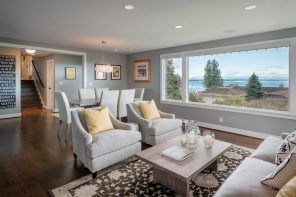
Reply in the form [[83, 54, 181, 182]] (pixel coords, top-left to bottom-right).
[[204, 59, 223, 89]]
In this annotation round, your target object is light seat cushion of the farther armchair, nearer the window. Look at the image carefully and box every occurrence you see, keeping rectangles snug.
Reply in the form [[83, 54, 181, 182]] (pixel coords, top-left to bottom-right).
[[147, 118, 182, 136]]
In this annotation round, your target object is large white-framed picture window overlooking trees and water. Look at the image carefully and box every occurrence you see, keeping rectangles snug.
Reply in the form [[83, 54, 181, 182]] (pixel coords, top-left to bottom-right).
[[161, 39, 296, 117]]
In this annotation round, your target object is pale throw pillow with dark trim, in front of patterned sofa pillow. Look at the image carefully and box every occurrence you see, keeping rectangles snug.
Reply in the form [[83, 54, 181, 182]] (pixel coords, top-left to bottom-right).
[[261, 147, 296, 189]]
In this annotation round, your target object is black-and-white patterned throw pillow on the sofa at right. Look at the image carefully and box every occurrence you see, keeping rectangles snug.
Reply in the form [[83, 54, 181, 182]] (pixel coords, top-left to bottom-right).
[[275, 131, 296, 165]]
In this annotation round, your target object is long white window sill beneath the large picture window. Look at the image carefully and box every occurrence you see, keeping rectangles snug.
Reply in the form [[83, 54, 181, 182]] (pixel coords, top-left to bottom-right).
[[160, 100, 296, 120]]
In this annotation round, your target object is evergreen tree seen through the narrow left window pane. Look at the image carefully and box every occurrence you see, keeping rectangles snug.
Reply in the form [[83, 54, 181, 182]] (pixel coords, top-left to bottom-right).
[[165, 59, 182, 100]]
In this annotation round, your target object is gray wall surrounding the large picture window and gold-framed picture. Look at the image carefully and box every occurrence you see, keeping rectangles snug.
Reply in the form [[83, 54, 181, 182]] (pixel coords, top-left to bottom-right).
[[127, 28, 296, 135]]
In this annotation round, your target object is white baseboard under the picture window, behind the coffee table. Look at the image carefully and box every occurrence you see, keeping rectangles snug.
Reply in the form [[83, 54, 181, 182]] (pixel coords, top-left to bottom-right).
[[199, 122, 274, 139]]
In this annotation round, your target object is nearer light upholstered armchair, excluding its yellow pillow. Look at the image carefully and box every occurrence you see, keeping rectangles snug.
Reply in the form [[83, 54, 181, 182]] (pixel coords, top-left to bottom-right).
[[72, 111, 141, 178]]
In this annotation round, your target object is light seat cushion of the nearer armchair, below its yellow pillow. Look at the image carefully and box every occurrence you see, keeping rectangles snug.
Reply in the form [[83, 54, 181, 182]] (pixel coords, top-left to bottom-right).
[[86, 129, 141, 158]]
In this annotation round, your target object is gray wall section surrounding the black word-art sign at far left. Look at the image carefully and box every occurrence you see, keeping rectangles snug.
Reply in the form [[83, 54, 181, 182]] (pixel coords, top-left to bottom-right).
[[0, 47, 21, 116]]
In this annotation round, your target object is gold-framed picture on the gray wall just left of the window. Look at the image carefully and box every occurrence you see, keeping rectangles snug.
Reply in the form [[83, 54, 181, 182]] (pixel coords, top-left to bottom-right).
[[133, 59, 151, 82]]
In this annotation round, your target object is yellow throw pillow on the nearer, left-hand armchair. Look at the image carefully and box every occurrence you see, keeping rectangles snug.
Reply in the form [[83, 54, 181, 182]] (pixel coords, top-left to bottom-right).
[[83, 106, 114, 135]]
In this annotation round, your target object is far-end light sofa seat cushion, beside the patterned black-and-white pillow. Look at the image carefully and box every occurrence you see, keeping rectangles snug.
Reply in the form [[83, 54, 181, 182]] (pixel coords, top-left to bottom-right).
[[251, 136, 283, 163]]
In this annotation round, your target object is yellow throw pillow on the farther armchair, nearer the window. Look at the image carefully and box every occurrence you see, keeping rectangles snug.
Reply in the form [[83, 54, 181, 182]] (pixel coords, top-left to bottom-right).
[[139, 99, 160, 120]]
